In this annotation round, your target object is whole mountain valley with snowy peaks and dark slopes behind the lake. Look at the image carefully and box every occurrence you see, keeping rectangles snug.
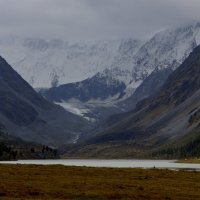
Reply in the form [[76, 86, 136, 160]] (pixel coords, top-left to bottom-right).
[[0, 23, 200, 159]]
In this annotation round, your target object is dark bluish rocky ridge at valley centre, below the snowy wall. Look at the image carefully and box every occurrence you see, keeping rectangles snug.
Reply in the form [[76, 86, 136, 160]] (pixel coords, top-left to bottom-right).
[[40, 73, 126, 102]]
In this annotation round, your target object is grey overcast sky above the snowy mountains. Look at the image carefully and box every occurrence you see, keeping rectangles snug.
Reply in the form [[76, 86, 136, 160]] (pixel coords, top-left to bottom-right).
[[0, 0, 200, 40]]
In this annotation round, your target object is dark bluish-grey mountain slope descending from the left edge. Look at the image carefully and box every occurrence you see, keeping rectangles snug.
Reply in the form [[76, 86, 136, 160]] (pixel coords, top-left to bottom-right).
[[0, 57, 88, 144]]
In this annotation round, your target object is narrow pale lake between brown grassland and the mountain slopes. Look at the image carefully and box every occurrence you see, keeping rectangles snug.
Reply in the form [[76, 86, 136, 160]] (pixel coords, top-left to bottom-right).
[[0, 159, 200, 170]]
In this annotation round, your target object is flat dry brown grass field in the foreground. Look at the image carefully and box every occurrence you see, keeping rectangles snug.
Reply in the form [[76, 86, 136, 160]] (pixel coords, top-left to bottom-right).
[[0, 165, 200, 200]]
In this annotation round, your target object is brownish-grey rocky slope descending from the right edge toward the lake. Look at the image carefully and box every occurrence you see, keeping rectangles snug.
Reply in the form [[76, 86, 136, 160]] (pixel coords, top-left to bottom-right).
[[67, 46, 200, 157]]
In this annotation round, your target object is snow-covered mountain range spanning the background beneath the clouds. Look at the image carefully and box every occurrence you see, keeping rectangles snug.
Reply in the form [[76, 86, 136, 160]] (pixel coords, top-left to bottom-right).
[[0, 23, 200, 119]]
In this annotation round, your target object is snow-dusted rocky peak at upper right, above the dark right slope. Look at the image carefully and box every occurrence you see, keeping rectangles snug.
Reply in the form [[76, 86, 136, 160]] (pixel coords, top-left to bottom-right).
[[133, 23, 200, 79]]
